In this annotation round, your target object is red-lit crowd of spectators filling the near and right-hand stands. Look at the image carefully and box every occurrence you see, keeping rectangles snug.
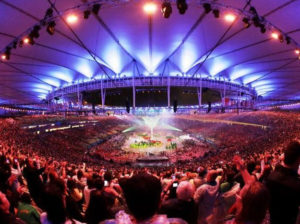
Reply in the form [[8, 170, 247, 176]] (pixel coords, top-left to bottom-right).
[[0, 112, 300, 224]]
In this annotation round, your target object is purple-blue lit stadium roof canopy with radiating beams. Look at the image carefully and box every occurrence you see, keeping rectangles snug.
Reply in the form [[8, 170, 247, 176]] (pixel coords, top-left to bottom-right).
[[0, 0, 300, 103]]
